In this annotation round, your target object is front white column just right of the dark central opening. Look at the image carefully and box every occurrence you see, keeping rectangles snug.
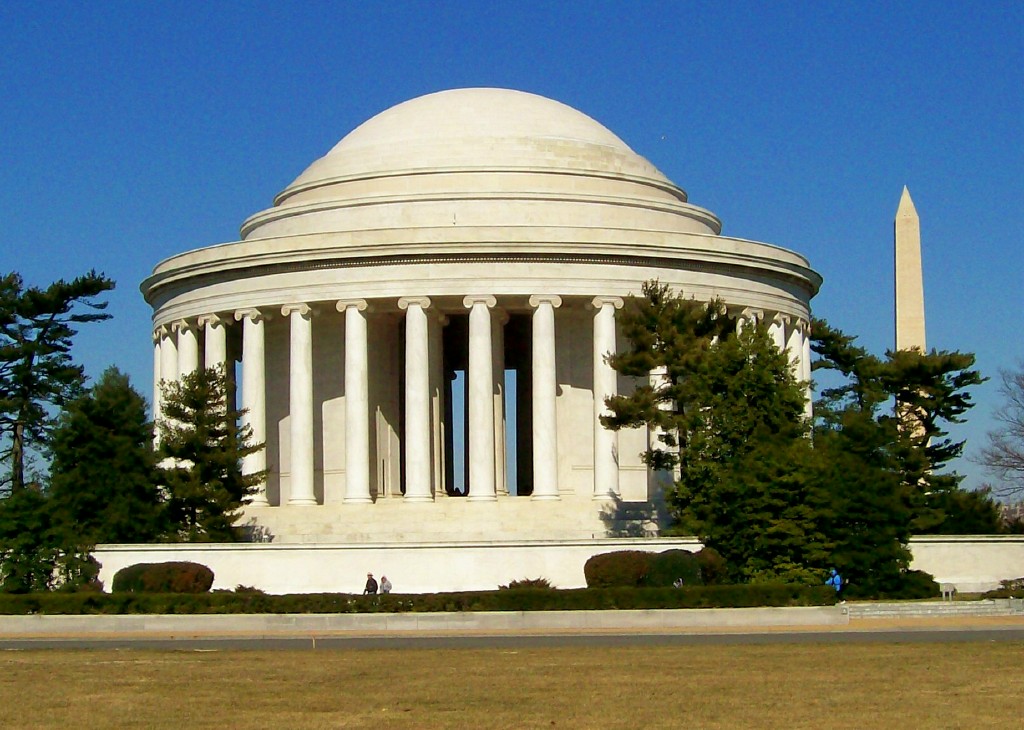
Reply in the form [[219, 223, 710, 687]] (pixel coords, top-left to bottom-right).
[[529, 295, 562, 500]]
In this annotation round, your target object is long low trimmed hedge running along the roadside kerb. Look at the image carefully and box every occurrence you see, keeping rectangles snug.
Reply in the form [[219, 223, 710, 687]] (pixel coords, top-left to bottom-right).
[[0, 584, 836, 615]]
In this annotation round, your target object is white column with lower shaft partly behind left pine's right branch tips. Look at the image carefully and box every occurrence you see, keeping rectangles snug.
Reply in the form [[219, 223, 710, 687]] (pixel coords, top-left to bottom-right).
[[234, 309, 268, 507]]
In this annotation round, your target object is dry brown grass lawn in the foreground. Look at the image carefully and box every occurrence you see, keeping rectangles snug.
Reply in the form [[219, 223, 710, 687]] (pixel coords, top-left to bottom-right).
[[0, 642, 1024, 730]]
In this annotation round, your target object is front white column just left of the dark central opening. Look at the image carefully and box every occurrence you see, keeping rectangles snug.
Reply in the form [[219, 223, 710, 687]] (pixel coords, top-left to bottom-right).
[[398, 297, 433, 502]]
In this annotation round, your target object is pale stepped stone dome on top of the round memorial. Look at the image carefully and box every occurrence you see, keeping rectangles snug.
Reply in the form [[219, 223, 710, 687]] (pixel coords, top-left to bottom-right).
[[242, 88, 721, 241]]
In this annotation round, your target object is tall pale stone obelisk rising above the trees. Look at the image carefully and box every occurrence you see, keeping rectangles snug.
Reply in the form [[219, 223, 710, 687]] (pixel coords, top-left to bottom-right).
[[895, 185, 926, 353]]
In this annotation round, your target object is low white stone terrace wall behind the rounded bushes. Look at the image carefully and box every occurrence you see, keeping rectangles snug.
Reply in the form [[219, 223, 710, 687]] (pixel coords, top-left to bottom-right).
[[88, 532, 1024, 594]]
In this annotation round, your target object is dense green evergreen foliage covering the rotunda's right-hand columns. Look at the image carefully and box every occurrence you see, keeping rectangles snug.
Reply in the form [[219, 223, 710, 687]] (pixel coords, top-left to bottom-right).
[[602, 282, 830, 583]]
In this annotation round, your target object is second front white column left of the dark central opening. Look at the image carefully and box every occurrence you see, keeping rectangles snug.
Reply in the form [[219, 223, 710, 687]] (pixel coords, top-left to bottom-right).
[[337, 299, 373, 504]]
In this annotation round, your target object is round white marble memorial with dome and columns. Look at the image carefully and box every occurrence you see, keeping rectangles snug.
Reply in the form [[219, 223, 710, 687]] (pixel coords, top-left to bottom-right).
[[130, 88, 821, 588]]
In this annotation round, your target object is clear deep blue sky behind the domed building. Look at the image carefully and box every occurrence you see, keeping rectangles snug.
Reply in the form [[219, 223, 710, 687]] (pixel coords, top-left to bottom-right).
[[0, 0, 1024, 484]]
